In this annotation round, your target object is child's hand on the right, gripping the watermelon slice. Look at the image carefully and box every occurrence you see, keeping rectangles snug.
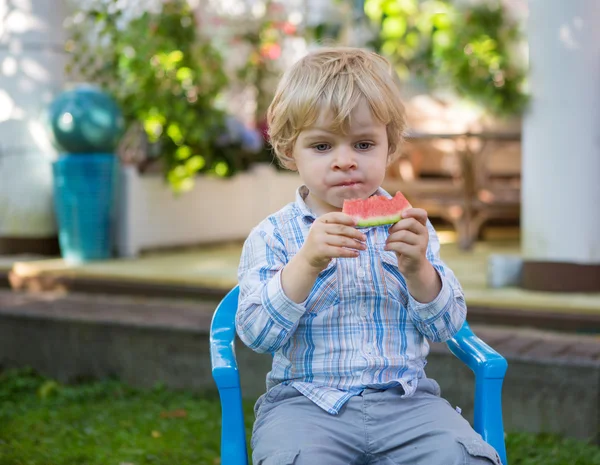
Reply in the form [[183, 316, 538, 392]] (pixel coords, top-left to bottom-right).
[[385, 208, 429, 277]]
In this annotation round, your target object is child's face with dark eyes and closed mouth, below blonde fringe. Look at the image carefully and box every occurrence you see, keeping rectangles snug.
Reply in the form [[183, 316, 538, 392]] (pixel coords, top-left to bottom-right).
[[293, 101, 388, 215]]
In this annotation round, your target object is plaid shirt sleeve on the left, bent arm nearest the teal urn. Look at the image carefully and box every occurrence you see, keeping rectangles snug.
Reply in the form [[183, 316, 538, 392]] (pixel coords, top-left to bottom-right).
[[235, 223, 306, 353]]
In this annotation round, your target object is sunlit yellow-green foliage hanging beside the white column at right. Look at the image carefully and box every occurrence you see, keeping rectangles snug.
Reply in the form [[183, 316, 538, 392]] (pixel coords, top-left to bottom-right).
[[365, 0, 527, 116]]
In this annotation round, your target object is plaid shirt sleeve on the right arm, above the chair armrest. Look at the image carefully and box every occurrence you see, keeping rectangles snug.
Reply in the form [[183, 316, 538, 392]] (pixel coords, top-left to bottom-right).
[[408, 221, 467, 342]]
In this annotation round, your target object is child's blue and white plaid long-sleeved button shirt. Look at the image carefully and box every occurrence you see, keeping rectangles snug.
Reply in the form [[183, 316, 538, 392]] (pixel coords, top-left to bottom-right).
[[236, 186, 467, 414]]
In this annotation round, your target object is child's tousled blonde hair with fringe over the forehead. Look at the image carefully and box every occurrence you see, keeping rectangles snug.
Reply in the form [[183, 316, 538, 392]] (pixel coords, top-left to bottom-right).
[[267, 47, 406, 168]]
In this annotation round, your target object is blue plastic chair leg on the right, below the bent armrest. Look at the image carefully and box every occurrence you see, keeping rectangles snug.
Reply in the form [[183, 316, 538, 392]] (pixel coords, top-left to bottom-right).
[[474, 378, 508, 465]]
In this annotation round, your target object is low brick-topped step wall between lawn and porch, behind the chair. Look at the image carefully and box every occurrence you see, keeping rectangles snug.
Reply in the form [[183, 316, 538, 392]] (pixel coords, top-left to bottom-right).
[[0, 290, 600, 441]]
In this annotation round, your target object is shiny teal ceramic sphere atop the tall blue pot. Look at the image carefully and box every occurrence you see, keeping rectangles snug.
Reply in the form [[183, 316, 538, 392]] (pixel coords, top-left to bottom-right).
[[48, 85, 125, 153]]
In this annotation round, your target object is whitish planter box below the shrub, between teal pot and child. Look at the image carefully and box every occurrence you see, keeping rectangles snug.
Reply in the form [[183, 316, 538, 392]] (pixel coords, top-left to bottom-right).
[[116, 165, 301, 257]]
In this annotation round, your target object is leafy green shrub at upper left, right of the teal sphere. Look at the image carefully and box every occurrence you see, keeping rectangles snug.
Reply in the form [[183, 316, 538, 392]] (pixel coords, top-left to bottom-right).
[[66, 0, 255, 191]]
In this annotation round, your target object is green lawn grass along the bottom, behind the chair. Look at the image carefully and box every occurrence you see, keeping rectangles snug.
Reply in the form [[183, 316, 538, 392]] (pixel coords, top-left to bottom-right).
[[0, 370, 600, 465]]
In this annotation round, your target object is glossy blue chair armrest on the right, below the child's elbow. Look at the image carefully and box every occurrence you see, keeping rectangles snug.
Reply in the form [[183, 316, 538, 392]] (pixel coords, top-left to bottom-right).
[[447, 321, 508, 379]]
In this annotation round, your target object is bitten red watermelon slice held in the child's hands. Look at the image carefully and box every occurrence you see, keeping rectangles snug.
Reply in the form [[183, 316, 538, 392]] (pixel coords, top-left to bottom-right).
[[342, 192, 412, 228]]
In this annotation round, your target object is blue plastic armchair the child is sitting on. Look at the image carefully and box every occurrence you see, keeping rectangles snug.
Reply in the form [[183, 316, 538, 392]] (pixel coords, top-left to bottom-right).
[[210, 286, 508, 465]]
